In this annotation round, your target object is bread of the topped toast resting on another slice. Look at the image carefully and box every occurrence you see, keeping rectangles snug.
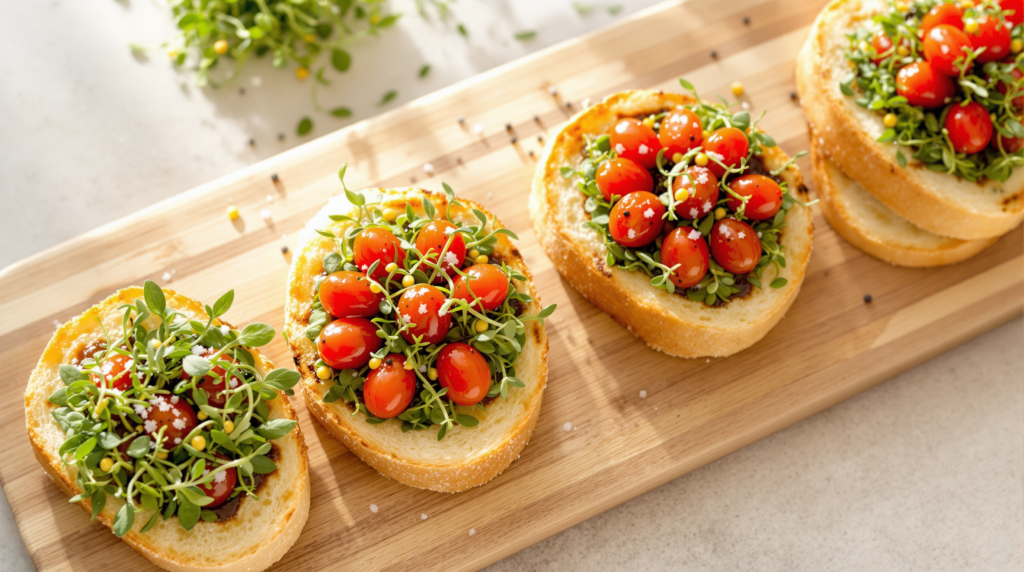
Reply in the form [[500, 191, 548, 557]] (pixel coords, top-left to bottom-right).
[[797, 0, 1024, 240]]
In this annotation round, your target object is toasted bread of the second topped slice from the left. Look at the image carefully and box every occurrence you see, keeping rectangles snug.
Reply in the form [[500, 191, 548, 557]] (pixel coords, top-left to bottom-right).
[[285, 188, 548, 492]]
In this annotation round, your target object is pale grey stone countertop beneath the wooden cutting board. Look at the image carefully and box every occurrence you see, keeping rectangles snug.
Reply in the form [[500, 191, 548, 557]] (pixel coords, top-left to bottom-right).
[[0, 0, 1024, 571]]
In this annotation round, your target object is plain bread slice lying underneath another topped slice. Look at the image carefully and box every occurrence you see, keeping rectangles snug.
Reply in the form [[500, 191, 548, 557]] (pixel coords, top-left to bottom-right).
[[811, 136, 999, 268]]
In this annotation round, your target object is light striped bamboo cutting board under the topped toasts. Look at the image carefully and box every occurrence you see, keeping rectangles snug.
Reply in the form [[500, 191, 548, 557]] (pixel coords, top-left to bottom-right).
[[0, 0, 1024, 572]]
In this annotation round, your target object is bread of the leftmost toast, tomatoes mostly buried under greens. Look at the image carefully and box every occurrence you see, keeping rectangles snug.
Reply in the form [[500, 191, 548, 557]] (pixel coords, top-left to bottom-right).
[[25, 287, 309, 572]]
